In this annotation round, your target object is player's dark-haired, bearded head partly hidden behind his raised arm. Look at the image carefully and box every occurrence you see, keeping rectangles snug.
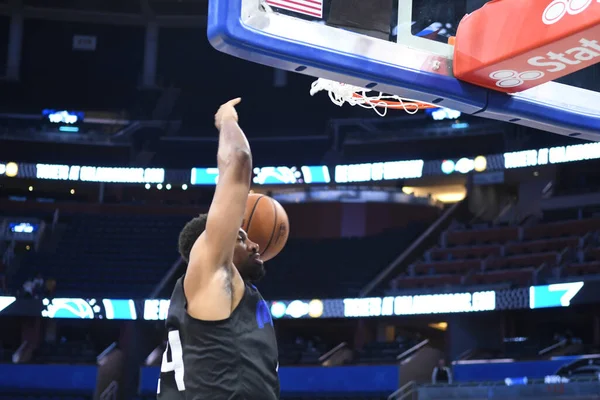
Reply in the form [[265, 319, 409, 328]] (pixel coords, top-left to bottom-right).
[[179, 214, 265, 281]]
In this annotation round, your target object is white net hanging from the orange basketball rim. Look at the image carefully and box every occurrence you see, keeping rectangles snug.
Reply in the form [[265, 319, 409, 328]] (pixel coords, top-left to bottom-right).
[[310, 78, 432, 117]]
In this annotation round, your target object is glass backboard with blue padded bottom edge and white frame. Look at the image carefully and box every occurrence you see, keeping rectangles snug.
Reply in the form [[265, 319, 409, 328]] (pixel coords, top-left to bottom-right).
[[208, 0, 600, 140]]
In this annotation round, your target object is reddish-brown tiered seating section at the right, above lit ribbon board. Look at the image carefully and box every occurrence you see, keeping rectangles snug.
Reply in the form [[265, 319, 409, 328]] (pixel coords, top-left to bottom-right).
[[392, 218, 600, 289]]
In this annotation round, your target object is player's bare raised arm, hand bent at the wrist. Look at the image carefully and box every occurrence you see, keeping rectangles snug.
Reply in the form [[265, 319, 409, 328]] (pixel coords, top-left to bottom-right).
[[184, 98, 252, 318]]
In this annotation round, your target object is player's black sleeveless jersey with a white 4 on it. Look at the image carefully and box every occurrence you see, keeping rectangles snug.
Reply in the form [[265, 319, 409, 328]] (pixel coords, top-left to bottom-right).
[[158, 277, 279, 400]]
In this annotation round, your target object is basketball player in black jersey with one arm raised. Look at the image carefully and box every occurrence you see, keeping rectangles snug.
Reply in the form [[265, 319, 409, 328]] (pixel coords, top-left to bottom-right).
[[158, 98, 279, 400]]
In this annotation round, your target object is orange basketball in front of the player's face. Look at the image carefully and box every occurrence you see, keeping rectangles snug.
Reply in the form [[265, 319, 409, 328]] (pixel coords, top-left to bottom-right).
[[242, 194, 290, 261]]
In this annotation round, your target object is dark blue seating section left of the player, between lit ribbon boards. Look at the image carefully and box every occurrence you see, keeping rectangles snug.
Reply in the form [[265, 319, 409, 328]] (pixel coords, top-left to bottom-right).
[[15, 215, 189, 298]]
